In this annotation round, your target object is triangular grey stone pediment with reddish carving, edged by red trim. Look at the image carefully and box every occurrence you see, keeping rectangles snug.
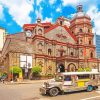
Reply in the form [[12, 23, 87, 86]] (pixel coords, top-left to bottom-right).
[[45, 26, 76, 44]]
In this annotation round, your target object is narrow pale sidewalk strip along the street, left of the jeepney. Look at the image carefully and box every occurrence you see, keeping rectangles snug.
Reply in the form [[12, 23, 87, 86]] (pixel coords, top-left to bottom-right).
[[4, 79, 47, 85]]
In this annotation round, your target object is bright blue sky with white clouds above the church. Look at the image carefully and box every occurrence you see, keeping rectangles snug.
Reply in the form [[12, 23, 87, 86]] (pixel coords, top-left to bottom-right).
[[0, 0, 100, 34]]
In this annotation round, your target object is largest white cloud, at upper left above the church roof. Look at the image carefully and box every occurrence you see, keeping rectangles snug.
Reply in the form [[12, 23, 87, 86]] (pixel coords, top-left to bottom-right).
[[0, 0, 33, 26]]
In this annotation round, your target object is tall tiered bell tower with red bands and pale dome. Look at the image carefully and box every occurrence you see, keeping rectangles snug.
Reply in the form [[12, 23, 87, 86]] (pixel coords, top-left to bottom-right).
[[70, 5, 96, 66]]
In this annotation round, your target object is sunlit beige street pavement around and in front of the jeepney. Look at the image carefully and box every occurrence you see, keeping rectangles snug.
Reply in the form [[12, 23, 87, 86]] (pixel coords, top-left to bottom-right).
[[0, 80, 100, 100]]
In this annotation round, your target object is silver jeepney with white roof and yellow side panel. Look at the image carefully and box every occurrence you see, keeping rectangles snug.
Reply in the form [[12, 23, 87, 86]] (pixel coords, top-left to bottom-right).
[[40, 72, 100, 96]]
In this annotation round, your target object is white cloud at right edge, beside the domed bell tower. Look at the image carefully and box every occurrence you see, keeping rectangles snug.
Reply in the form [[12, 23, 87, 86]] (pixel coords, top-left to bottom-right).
[[87, 6, 100, 35]]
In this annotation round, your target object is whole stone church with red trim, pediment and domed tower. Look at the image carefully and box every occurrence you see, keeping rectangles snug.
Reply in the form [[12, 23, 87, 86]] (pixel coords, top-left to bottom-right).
[[1, 5, 98, 78]]
